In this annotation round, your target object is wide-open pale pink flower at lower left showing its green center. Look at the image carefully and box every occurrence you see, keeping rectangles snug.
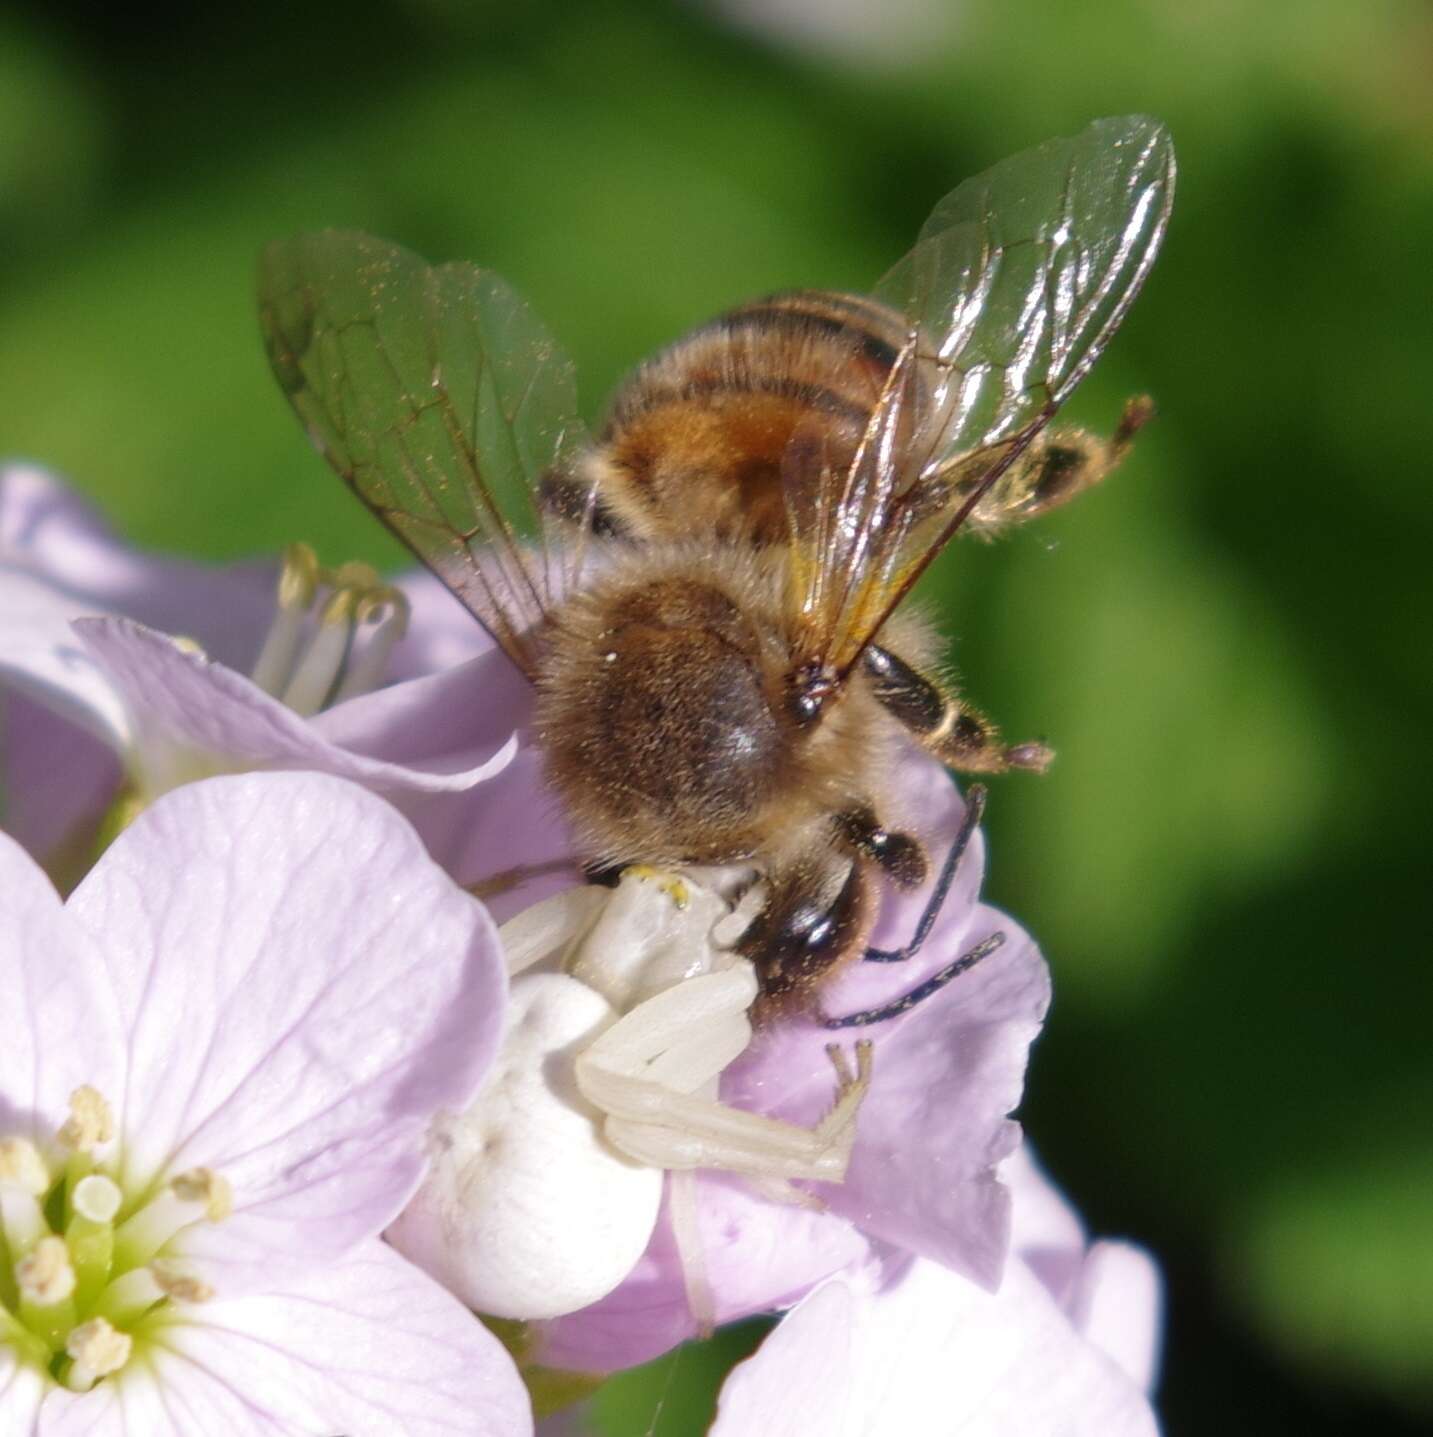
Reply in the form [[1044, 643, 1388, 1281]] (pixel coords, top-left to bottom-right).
[[0, 773, 530, 1437]]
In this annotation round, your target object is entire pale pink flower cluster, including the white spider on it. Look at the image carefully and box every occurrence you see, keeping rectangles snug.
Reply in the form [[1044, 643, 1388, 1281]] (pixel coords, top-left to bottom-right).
[[0, 466, 1158, 1437]]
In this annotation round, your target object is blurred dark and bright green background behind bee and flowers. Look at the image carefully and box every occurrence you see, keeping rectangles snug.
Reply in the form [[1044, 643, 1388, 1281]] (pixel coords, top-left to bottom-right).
[[0, 0, 1433, 1437]]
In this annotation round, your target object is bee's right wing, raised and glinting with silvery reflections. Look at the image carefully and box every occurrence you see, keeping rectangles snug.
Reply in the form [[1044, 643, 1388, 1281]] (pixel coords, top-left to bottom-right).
[[783, 115, 1174, 678]]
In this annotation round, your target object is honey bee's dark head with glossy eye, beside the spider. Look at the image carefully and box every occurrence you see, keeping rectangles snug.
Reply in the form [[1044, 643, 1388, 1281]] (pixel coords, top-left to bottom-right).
[[737, 859, 875, 1010]]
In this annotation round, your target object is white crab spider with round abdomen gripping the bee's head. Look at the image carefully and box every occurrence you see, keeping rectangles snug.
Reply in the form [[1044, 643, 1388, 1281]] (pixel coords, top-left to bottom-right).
[[388, 869, 870, 1319]]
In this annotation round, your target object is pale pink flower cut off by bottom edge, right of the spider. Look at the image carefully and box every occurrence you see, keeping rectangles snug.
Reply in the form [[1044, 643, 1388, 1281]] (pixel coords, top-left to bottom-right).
[[711, 1154, 1160, 1437]]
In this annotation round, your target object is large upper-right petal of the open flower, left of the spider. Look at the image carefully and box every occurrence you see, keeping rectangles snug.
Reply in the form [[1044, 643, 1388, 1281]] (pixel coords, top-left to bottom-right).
[[70, 773, 507, 1293]]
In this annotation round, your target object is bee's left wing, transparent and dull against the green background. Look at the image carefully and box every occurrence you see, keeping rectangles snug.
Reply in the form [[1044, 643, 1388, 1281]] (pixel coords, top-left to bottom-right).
[[259, 230, 584, 675]]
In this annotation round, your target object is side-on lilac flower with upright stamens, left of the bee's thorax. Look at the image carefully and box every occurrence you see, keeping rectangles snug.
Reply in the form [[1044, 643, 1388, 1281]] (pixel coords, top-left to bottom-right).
[[0, 464, 562, 896]]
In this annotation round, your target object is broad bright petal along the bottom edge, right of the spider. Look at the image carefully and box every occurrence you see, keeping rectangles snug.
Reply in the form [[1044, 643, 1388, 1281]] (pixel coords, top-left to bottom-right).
[[711, 1260, 1157, 1437]]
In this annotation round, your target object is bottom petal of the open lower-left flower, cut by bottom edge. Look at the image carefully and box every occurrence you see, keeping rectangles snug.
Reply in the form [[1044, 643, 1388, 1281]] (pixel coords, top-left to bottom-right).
[[36, 1242, 532, 1437]]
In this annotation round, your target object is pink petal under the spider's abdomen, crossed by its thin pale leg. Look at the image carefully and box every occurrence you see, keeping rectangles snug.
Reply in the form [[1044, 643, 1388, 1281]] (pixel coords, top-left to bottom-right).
[[535, 1174, 871, 1372]]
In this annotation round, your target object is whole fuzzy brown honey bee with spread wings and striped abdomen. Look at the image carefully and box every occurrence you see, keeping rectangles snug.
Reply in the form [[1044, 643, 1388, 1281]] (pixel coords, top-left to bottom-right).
[[260, 116, 1174, 1023]]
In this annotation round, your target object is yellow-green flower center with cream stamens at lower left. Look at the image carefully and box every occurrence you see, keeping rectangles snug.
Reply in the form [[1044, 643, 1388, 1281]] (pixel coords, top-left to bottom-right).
[[0, 1086, 233, 1392]]
